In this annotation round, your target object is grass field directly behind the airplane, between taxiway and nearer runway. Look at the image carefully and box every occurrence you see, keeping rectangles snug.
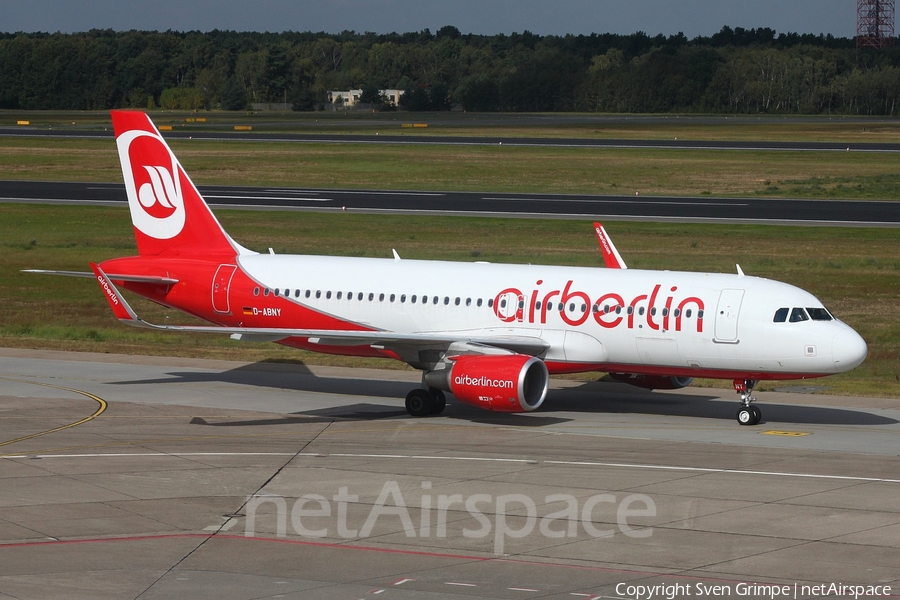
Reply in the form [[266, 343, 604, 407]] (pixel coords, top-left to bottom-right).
[[0, 204, 900, 397]]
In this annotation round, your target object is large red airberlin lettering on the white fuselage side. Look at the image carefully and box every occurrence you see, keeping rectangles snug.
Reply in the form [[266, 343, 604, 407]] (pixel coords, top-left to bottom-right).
[[494, 279, 704, 333]]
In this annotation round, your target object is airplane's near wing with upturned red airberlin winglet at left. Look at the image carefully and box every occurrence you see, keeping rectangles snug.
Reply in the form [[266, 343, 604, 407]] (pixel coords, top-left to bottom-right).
[[91, 263, 550, 355]]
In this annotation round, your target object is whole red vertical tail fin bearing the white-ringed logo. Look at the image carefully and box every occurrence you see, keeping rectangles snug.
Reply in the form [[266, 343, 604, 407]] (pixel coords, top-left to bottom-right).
[[111, 110, 241, 257]]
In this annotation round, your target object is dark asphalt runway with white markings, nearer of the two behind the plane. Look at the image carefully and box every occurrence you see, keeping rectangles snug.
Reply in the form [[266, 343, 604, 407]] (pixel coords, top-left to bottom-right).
[[0, 181, 900, 227]]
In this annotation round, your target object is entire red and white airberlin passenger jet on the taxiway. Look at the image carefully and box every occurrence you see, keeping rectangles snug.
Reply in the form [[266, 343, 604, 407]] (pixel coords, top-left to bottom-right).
[[28, 111, 867, 425]]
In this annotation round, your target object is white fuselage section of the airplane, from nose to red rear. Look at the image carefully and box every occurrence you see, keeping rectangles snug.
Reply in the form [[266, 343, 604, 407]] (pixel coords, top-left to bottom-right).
[[239, 254, 866, 379]]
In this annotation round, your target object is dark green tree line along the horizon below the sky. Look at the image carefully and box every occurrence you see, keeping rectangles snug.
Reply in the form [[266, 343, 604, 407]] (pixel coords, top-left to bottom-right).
[[0, 26, 900, 115]]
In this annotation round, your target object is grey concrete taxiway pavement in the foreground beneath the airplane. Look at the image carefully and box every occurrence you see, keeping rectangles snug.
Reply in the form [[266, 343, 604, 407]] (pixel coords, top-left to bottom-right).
[[0, 349, 900, 599]]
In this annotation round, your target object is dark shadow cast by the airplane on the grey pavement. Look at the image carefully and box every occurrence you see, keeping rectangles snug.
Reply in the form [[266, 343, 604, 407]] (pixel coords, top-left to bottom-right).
[[112, 363, 900, 427]]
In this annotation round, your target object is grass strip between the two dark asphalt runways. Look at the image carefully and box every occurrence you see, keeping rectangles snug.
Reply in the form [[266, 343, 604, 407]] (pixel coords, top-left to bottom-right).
[[0, 137, 900, 200]]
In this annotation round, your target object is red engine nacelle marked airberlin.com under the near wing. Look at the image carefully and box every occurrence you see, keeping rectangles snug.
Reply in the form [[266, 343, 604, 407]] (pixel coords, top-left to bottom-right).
[[425, 354, 550, 412]]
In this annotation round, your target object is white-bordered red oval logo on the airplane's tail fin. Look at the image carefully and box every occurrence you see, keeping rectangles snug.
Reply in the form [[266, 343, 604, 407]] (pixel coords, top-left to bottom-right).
[[116, 129, 185, 240]]
